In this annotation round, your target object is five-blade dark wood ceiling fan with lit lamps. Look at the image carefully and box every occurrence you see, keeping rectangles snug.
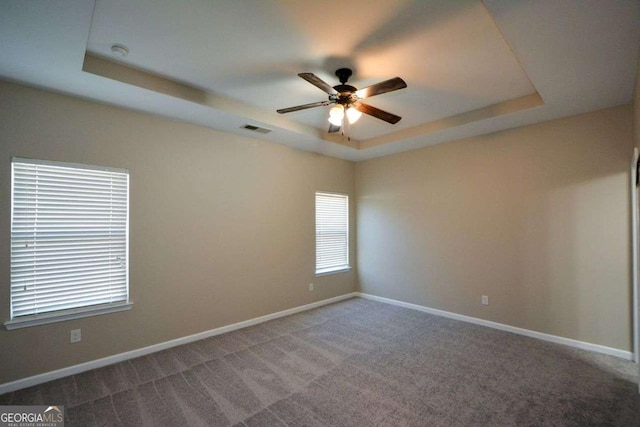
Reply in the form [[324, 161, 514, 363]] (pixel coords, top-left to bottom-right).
[[277, 68, 407, 133]]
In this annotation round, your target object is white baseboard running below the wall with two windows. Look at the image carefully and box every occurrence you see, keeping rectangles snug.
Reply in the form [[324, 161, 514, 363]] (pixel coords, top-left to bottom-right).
[[0, 292, 358, 394]]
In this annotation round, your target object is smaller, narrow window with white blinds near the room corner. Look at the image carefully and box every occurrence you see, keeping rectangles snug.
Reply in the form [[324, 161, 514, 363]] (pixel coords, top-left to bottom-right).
[[316, 192, 350, 275]]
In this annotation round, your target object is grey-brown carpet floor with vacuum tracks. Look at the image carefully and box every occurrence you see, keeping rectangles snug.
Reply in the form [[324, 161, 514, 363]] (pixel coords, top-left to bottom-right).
[[0, 298, 640, 427]]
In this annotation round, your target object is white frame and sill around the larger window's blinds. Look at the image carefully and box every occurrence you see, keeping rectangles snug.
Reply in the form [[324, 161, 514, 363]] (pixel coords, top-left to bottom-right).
[[4, 157, 133, 330]]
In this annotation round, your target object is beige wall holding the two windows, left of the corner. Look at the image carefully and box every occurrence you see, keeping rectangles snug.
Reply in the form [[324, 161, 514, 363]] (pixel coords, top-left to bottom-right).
[[0, 83, 357, 383]]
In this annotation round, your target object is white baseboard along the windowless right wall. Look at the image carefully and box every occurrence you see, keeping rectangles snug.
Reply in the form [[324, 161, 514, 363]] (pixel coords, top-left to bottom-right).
[[356, 292, 634, 361]]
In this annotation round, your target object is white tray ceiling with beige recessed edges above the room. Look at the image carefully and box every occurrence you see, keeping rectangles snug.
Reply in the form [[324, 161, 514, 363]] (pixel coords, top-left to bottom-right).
[[0, 0, 640, 160]]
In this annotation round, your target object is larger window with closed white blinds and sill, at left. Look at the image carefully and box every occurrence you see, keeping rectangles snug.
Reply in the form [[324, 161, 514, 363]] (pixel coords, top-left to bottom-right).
[[5, 158, 131, 329]]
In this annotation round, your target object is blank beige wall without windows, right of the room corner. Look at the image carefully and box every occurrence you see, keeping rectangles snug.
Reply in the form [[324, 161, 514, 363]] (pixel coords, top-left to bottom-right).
[[356, 106, 633, 350]]
